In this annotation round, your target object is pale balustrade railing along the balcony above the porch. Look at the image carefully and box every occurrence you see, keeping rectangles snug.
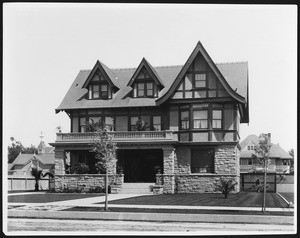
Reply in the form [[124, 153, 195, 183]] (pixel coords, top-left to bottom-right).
[[56, 131, 175, 142]]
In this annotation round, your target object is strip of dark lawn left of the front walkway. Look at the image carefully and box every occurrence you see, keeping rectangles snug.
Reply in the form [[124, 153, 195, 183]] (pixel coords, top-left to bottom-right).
[[8, 193, 103, 203]]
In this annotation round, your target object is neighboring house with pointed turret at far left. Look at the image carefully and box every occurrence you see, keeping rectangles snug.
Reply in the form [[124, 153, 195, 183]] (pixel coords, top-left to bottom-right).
[[8, 141, 55, 177]]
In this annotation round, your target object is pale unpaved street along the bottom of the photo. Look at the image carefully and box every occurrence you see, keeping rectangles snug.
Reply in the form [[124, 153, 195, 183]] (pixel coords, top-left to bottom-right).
[[7, 218, 294, 234]]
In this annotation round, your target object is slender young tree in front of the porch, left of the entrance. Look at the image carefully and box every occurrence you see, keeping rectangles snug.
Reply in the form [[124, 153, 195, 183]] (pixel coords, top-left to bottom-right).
[[92, 127, 117, 211]]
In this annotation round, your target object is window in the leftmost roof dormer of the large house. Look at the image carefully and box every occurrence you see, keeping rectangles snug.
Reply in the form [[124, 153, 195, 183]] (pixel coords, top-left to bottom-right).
[[89, 74, 112, 99]]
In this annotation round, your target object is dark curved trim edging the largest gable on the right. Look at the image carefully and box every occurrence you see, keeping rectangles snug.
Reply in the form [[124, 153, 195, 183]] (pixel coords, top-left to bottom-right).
[[156, 41, 246, 105]]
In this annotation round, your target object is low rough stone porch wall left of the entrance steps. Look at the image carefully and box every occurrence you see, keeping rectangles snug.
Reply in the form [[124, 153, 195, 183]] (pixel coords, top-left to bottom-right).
[[55, 174, 124, 191]]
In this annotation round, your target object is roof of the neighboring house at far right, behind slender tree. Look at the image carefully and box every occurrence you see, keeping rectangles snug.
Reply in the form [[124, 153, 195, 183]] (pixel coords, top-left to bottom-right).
[[240, 135, 293, 159]]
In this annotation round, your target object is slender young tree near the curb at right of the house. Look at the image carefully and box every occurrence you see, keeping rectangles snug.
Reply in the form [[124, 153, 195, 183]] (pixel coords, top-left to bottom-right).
[[253, 134, 271, 212]]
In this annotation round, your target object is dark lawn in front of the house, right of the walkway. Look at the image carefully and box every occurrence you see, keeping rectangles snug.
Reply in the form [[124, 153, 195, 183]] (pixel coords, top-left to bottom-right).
[[100, 192, 287, 208]]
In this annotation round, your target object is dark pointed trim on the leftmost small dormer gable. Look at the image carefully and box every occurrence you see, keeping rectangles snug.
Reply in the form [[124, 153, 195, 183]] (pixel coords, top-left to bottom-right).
[[82, 60, 119, 89]]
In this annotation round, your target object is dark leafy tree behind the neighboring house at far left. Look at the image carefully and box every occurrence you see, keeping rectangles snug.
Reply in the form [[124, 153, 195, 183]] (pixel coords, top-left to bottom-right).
[[8, 137, 38, 164]]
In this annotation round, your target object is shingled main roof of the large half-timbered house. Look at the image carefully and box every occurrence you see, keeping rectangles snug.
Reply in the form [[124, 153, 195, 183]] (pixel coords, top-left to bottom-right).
[[56, 42, 248, 122]]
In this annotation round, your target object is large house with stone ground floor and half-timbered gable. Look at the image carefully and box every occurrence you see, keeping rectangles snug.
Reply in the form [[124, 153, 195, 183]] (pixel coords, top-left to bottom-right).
[[50, 42, 249, 193]]
